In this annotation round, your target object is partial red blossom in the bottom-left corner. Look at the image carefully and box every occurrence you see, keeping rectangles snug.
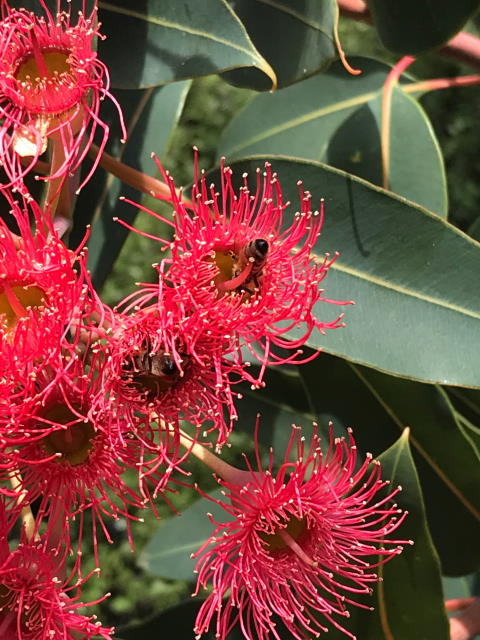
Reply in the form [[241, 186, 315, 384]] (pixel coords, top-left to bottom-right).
[[0, 541, 113, 640]]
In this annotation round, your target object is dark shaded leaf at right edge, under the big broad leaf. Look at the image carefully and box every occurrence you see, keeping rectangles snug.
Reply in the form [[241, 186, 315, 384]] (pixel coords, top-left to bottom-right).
[[351, 365, 480, 575]]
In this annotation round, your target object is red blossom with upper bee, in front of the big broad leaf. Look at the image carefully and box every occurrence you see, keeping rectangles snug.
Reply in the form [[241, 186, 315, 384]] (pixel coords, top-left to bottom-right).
[[133, 154, 345, 379]]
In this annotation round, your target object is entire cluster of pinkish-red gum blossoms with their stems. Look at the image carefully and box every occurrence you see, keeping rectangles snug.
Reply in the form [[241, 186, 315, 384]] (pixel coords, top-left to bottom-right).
[[0, 0, 405, 640]]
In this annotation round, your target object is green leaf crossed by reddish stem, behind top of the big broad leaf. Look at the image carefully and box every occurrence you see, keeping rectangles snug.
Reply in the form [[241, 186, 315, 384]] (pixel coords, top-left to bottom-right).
[[219, 58, 448, 217]]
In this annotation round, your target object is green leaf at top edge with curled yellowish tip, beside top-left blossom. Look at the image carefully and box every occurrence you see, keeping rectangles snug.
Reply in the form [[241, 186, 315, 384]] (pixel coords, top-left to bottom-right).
[[98, 0, 276, 89]]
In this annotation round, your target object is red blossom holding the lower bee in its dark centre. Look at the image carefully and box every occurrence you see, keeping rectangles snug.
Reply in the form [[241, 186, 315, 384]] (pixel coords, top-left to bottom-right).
[[105, 282, 253, 446]]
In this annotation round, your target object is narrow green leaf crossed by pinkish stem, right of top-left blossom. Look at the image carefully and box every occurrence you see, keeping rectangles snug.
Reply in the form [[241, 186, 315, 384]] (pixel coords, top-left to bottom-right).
[[77, 81, 190, 288]]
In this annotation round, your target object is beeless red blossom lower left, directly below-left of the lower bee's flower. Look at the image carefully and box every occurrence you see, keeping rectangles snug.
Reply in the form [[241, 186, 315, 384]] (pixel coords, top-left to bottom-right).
[[2, 352, 158, 564]]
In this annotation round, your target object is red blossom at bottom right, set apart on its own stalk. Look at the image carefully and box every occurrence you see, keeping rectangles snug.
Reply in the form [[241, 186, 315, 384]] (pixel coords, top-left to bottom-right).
[[195, 427, 409, 640]]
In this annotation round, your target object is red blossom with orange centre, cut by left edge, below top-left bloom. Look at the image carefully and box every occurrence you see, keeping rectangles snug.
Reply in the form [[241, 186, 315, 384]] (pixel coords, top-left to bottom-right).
[[0, 195, 104, 439]]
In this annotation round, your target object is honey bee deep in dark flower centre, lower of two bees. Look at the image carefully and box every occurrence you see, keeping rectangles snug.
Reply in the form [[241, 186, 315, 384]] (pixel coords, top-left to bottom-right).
[[123, 344, 187, 399]]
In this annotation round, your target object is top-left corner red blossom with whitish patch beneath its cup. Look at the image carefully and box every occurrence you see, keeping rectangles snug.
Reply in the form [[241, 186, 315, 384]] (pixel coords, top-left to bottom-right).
[[0, 0, 126, 188]]
